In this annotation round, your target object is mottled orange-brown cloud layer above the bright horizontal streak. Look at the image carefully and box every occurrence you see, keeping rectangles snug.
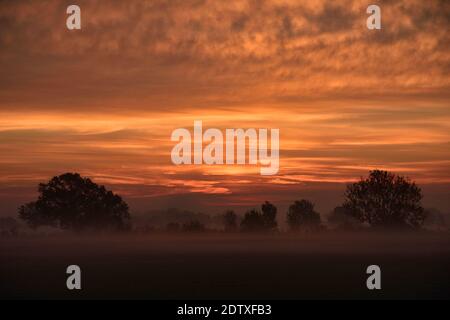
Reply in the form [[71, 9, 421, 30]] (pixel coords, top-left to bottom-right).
[[0, 0, 450, 112]]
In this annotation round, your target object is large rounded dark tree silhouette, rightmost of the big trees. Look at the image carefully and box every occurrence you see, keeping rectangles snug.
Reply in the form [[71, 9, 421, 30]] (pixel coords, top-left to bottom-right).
[[343, 170, 425, 228]]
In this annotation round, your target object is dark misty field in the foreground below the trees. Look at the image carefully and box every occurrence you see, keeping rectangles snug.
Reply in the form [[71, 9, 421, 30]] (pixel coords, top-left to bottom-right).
[[0, 233, 450, 299]]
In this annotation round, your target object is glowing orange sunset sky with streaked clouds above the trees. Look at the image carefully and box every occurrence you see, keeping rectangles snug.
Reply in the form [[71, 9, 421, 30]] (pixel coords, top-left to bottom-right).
[[0, 0, 450, 215]]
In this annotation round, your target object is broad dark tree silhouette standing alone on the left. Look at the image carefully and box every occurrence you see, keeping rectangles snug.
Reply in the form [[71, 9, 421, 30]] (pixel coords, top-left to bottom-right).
[[19, 173, 130, 231]]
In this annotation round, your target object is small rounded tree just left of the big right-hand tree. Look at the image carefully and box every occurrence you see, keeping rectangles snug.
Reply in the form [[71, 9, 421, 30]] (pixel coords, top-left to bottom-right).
[[287, 200, 320, 231]]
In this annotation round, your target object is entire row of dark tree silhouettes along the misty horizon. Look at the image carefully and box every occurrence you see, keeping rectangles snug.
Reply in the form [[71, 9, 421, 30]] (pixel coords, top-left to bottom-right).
[[14, 170, 425, 232]]
